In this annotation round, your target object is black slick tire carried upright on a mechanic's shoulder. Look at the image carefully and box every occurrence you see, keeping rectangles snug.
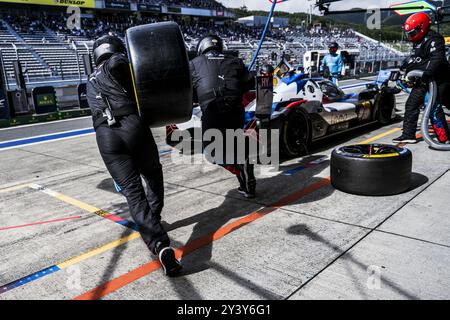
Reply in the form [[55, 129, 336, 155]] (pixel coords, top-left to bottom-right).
[[126, 22, 193, 127]]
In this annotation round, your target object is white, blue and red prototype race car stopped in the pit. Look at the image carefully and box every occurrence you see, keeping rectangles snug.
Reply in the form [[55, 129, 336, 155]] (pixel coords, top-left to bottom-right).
[[166, 64, 396, 157]]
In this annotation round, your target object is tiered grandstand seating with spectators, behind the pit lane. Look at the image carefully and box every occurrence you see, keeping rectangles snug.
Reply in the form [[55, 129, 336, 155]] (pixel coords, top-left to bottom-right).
[[0, 8, 406, 85]]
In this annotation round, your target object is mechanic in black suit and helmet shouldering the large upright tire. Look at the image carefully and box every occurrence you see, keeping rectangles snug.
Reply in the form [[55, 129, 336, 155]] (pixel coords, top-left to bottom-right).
[[87, 35, 181, 276]]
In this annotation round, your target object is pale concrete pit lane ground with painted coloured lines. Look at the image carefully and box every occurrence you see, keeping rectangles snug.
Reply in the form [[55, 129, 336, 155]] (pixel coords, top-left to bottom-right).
[[0, 78, 450, 299]]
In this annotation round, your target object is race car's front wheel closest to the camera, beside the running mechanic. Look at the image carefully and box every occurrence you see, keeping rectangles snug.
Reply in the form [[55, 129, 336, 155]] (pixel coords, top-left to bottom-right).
[[280, 107, 312, 158]]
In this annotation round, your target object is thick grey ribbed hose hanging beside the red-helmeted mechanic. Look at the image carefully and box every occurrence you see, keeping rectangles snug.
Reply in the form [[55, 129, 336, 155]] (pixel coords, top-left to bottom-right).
[[407, 70, 450, 151]]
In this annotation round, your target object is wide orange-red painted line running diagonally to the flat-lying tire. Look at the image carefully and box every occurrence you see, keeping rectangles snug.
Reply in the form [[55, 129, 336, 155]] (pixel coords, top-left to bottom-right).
[[74, 177, 330, 300]]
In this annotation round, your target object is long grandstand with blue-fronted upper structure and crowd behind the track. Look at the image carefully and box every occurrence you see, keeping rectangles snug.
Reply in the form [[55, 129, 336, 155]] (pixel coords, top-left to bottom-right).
[[0, 0, 403, 124]]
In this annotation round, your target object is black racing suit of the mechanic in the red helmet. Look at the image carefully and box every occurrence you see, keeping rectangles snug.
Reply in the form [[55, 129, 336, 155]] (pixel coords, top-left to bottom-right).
[[402, 30, 450, 142]]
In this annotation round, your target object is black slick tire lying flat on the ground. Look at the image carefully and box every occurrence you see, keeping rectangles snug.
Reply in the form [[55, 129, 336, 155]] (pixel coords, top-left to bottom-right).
[[331, 144, 412, 196]]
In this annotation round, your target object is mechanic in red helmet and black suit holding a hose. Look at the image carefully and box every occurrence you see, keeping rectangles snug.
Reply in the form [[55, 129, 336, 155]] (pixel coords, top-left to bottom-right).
[[393, 12, 450, 143]]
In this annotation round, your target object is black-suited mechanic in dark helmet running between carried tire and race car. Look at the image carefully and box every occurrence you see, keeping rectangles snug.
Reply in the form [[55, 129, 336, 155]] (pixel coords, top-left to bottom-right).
[[191, 35, 256, 198]]
